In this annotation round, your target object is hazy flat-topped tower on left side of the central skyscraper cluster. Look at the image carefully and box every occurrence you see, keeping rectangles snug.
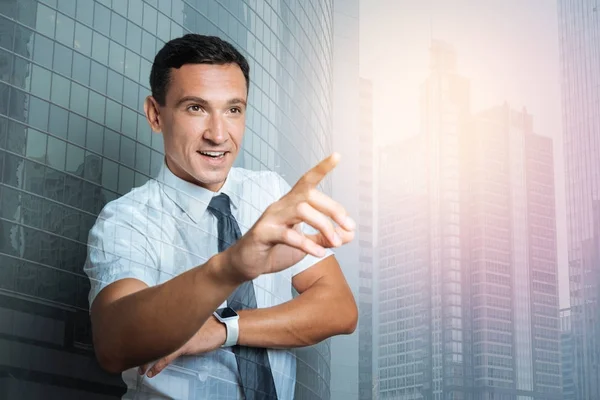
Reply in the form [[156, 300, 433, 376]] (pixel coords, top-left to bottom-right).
[[374, 135, 432, 400]]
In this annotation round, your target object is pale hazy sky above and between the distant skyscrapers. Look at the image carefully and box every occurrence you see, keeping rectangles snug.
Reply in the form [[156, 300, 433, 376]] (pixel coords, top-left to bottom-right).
[[360, 0, 569, 308]]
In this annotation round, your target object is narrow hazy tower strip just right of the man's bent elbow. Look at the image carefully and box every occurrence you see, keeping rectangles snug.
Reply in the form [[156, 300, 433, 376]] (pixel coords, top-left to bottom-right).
[[358, 78, 375, 400]]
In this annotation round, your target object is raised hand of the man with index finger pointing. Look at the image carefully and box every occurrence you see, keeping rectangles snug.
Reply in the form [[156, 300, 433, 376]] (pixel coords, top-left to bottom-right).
[[224, 153, 356, 282]]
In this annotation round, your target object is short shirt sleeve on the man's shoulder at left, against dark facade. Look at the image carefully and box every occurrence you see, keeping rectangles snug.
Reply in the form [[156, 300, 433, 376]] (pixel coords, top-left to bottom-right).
[[84, 200, 158, 307]]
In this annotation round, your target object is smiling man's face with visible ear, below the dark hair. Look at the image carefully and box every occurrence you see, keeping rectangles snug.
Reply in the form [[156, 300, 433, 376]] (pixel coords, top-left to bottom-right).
[[144, 64, 247, 191]]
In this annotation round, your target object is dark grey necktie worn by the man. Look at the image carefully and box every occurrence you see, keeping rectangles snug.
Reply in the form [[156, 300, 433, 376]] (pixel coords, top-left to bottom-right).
[[208, 193, 277, 400]]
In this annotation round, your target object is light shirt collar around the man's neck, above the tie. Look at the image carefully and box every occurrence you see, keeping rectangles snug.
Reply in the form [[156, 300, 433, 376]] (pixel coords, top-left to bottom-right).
[[156, 158, 240, 223]]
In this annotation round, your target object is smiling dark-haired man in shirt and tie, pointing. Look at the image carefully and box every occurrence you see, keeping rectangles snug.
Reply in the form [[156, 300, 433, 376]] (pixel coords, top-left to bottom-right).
[[84, 34, 357, 399]]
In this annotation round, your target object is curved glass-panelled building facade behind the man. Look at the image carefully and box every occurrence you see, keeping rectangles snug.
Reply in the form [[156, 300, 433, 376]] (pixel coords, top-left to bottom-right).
[[0, 0, 333, 399]]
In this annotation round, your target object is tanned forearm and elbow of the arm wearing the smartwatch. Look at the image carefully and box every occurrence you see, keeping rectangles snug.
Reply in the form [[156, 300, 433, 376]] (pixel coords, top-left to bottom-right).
[[238, 283, 357, 348]]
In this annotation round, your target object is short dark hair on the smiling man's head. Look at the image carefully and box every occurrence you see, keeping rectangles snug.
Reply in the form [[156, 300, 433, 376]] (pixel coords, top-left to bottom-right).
[[150, 33, 250, 106]]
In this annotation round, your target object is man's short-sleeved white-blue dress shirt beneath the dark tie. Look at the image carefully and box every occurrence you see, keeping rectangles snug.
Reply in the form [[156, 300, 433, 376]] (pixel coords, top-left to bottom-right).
[[84, 163, 333, 400]]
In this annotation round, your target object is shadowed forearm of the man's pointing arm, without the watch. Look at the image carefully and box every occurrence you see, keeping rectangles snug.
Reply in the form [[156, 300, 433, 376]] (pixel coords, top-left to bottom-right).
[[93, 255, 237, 372]]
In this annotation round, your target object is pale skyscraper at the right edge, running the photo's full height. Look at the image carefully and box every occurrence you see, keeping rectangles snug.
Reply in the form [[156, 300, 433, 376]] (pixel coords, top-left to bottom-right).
[[557, 0, 600, 399]]
